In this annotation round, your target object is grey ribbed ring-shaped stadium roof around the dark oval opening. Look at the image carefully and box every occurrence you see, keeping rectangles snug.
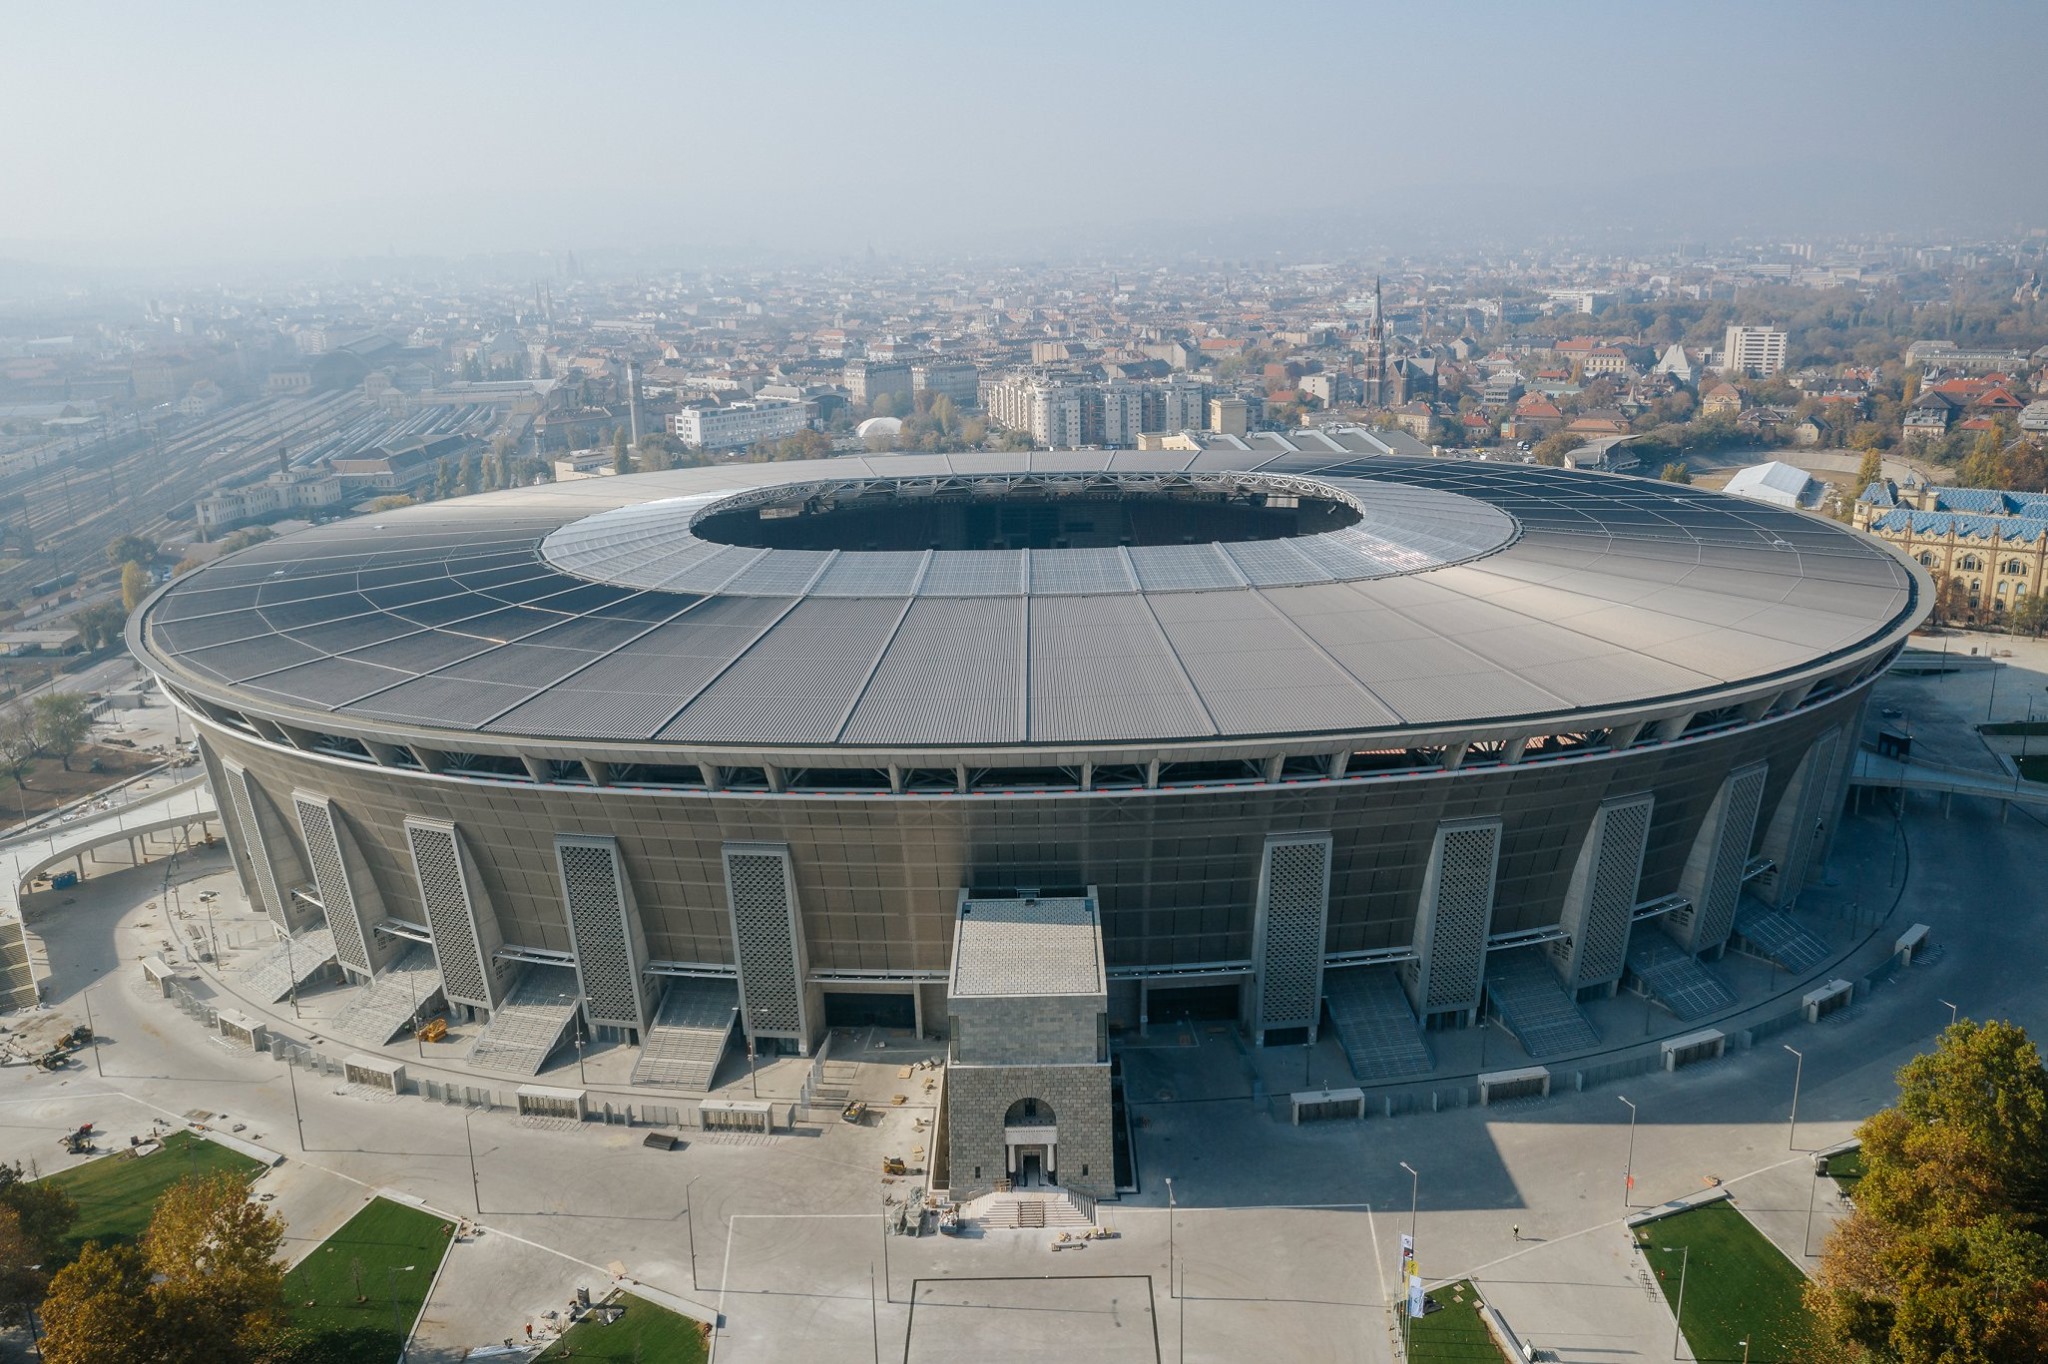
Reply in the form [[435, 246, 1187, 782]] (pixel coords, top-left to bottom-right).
[[131, 438, 1919, 750]]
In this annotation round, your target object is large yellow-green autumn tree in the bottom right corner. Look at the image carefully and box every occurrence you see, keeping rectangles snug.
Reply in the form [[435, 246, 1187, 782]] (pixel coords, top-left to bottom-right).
[[1806, 1020, 2048, 1364]]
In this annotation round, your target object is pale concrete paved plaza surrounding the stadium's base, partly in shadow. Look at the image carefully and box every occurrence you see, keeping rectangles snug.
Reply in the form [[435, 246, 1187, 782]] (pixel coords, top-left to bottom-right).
[[0, 641, 2048, 1364]]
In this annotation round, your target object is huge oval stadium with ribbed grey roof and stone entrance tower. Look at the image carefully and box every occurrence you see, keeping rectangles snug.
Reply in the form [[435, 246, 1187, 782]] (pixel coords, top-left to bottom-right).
[[129, 430, 1929, 1192]]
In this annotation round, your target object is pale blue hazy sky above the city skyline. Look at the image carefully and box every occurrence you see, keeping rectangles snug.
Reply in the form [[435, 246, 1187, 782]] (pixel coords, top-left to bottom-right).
[[0, 0, 2048, 264]]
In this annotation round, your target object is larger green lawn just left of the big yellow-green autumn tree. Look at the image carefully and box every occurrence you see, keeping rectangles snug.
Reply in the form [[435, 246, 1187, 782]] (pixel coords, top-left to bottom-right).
[[1636, 1202, 1806, 1364]]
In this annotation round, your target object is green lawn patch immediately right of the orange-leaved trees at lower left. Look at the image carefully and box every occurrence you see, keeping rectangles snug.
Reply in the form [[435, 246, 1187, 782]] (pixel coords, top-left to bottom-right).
[[285, 1198, 455, 1364]]
